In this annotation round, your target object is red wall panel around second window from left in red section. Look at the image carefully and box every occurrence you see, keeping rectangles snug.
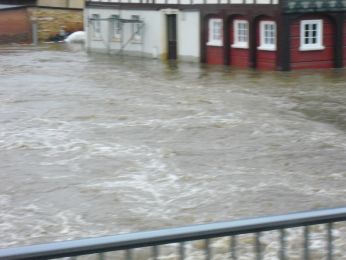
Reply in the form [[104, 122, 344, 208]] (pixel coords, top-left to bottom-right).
[[229, 16, 250, 68]]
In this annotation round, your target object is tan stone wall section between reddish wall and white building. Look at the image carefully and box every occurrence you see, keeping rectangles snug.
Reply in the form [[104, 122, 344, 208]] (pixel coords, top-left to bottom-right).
[[28, 7, 83, 41]]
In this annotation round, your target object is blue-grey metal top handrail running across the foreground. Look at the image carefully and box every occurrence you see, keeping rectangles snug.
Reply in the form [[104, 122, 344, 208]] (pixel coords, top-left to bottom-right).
[[0, 207, 346, 260]]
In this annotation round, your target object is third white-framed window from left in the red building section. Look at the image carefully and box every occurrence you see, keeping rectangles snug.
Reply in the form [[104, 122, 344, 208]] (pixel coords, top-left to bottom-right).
[[258, 21, 276, 51]]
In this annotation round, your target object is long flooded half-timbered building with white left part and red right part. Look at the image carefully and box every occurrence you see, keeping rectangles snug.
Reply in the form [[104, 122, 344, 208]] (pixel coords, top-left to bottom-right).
[[84, 0, 346, 70]]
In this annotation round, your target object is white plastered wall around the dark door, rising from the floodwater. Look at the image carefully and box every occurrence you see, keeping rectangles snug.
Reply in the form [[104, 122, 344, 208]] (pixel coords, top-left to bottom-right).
[[84, 8, 200, 61]]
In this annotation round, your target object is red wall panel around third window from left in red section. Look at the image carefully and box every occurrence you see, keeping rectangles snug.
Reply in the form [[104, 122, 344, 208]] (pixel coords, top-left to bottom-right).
[[256, 18, 278, 70]]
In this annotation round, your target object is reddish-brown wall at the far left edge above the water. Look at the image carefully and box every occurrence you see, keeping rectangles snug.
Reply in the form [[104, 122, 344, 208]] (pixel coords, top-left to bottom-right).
[[0, 9, 31, 43]]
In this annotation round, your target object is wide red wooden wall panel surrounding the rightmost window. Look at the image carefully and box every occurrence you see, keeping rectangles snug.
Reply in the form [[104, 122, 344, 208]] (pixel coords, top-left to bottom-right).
[[291, 15, 334, 69]]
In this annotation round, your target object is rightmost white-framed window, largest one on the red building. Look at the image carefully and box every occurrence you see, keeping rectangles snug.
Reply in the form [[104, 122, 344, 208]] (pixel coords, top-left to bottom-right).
[[299, 20, 324, 51]]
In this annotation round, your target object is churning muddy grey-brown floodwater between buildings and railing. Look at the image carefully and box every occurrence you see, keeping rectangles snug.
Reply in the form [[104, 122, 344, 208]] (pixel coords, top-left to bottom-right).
[[0, 45, 346, 256]]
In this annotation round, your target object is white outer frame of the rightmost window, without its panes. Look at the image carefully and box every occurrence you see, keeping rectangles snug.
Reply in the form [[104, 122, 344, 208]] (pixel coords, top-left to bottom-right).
[[299, 19, 325, 51]]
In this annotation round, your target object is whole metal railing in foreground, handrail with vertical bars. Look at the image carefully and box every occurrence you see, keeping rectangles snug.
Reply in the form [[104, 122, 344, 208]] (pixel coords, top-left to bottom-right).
[[0, 207, 346, 260]]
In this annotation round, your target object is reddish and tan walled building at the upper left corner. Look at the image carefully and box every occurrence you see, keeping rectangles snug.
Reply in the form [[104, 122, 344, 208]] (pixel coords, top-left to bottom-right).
[[0, 0, 84, 43]]
